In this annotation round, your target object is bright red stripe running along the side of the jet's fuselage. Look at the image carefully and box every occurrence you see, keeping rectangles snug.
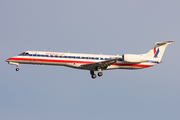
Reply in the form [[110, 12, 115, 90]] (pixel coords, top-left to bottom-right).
[[7, 58, 153, 68]]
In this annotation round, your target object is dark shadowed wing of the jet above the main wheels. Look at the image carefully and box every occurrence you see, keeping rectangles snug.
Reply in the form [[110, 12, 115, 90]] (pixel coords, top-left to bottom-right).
[[80, 58, 122, 71]]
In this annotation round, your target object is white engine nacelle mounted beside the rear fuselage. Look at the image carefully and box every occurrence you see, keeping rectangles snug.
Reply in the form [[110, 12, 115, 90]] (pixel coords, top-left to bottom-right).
[[122, 54, 147, 63]]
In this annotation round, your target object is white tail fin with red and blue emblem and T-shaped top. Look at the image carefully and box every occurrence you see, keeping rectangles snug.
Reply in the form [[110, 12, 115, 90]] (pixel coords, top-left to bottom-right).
[[143, 41, 174, 62]]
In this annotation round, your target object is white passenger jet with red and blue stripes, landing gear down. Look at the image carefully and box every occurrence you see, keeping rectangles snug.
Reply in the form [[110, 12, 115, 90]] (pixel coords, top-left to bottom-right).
[[6, 41, 174, 79]]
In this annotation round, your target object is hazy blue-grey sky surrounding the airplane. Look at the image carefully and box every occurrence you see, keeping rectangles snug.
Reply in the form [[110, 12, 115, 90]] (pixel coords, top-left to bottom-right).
[[0, 0, 180, 120]]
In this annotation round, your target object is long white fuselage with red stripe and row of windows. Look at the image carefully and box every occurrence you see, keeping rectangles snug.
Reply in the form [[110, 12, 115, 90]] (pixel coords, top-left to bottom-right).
[[6, 51, 157, 70]]
